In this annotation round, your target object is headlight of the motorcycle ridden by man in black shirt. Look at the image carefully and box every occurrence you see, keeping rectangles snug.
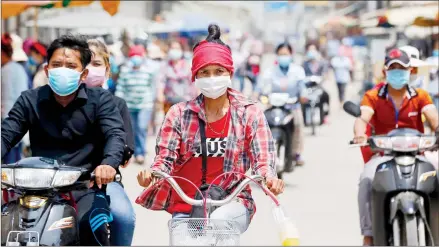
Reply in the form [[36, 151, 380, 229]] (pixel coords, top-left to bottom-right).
[[14, 168, 55, 189]]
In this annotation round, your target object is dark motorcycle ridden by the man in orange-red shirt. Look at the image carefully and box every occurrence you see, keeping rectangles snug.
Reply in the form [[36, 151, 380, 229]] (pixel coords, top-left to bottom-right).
[[343, 101, 439, 246]]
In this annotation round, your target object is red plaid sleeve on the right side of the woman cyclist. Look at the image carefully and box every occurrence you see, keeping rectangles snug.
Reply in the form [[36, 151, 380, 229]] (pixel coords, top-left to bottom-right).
[[247, 105, 277, 177]]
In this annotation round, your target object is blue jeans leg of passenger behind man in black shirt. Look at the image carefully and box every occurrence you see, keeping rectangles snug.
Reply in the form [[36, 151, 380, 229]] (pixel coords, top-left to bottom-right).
[[107, 182, 136, 246]]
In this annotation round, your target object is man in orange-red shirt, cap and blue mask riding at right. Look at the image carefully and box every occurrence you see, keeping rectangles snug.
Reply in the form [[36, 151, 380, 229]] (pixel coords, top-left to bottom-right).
[[354, 49, 438, 245]]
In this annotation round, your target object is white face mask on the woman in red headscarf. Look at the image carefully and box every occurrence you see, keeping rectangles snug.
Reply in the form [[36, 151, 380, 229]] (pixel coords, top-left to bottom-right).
[[195, 75, 232, 99]]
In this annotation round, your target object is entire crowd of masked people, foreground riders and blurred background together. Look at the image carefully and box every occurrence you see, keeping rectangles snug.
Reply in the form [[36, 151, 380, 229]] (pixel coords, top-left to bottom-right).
[[1, 21, 438, 246]]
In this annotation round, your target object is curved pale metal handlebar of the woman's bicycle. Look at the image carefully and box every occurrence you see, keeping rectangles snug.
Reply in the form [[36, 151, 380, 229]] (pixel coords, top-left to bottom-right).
[[152, 171, 264, 206]]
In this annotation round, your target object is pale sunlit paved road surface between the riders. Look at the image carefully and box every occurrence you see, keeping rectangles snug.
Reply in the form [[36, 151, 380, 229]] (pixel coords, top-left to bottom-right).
[[119, 69, 362, 246]]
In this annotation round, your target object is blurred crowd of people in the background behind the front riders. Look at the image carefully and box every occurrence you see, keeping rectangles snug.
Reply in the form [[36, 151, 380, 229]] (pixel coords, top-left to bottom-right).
[[2, 27, 370, 168]]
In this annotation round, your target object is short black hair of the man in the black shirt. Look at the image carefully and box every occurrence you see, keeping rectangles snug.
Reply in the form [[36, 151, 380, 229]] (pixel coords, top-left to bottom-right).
[[47, 34, 92, 69]]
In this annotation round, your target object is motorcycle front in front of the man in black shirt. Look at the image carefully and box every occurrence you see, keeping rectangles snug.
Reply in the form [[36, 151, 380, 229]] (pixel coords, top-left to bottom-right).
[[1, 157, 120, 246]]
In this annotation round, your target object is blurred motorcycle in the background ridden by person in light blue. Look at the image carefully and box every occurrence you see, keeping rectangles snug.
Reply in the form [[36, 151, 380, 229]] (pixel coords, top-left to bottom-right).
[[260, 93, 298, 178]]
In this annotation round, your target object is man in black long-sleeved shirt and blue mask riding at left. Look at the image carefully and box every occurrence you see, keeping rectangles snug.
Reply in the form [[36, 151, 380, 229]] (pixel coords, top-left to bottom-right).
[[1, 35, 125, 246]]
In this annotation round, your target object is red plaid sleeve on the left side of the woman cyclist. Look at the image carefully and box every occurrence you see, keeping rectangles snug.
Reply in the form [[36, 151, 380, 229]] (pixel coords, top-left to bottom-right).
[[151, 104, 181, 174]]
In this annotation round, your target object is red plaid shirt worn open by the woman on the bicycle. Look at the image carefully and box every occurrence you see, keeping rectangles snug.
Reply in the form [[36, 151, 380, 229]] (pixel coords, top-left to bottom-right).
[[136, 89, 277, 218]]
